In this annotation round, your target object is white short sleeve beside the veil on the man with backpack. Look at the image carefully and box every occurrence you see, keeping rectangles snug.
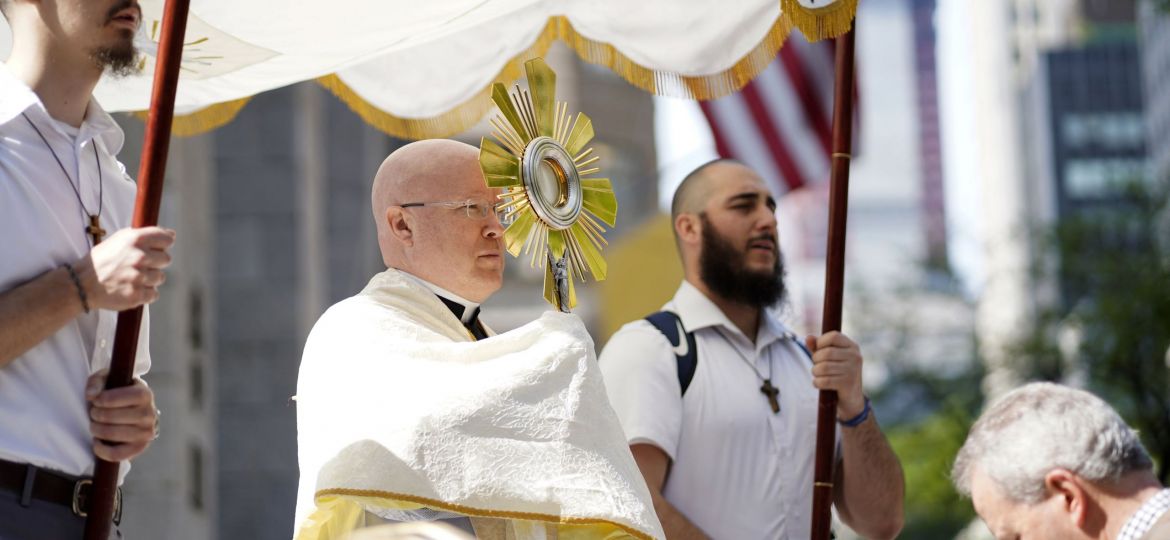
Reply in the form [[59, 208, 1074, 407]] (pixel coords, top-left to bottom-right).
[[598, 320, 682, 461]]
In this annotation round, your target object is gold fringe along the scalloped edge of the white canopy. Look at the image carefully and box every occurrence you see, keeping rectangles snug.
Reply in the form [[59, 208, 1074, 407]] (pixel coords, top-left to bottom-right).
[[136, 0, 859, 139]]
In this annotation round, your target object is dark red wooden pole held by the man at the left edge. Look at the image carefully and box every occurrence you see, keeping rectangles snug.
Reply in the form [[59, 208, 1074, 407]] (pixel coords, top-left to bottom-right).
[[85, 0, 191, 540]]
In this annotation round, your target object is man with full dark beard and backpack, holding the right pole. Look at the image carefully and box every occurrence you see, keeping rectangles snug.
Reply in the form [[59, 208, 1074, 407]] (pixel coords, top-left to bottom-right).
[[600, 160, 904, 540]]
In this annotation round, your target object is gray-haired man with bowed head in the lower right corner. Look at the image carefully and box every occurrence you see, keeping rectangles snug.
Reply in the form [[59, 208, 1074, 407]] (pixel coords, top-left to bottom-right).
[[952, 382, 1170, 540]]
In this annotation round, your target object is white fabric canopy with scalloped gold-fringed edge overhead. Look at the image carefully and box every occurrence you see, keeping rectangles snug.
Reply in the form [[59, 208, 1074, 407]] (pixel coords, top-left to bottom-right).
[[0, 0, 858, 138]]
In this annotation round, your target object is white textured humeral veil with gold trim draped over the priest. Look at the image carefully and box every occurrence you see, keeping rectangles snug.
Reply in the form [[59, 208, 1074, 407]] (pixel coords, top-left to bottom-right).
[[294, 270, 665, 540]]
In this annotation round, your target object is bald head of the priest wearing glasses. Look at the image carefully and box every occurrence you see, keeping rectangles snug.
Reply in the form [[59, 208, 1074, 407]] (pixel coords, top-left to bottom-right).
[[370, 139, 503, 302]]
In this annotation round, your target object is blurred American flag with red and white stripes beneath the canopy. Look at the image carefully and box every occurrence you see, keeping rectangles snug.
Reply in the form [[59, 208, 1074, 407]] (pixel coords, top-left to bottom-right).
[[700, 33, 859, 196]]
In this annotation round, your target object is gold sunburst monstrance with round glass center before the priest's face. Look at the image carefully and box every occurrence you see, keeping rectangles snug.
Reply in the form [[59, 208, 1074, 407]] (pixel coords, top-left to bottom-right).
[[480, 58, 618, 311]]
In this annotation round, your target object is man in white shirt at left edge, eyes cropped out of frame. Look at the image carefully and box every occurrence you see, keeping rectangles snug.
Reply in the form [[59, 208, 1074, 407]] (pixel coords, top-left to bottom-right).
[[0, 0, 174, 540]]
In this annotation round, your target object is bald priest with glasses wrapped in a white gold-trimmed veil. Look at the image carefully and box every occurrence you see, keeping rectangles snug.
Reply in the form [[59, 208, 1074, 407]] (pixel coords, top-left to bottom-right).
[[294, 140, 662, 540]]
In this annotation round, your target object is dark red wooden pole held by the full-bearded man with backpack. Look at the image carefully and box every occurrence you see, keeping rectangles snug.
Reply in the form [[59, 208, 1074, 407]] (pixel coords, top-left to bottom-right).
[[812, 21, 856, 540]]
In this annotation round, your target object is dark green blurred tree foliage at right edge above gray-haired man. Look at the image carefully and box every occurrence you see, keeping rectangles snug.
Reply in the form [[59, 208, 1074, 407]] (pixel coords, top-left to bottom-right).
[[1016, 186, 1170, 484]]
